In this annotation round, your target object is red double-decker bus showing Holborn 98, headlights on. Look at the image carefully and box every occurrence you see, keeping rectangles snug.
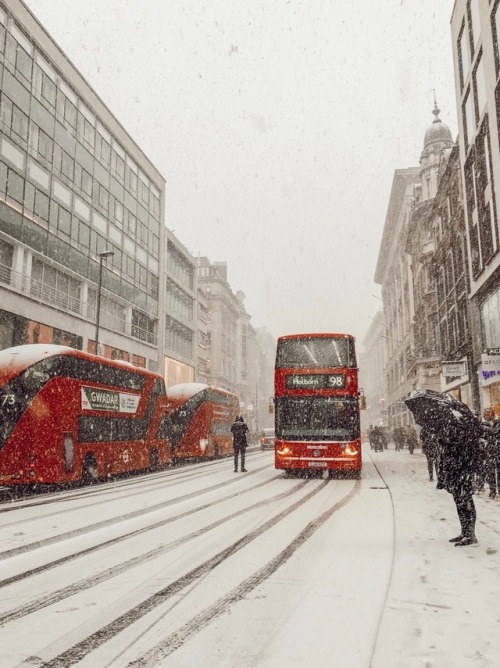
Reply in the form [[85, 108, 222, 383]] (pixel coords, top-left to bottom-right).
[[274, 334, 361, 477]]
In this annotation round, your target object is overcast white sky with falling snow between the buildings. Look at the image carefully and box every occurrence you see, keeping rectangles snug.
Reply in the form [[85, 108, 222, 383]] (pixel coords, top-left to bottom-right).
[[25, 0, 457, 343]]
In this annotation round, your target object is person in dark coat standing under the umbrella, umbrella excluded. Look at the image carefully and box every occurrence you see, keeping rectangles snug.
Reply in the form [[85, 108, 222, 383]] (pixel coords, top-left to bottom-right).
[[437, 420, 482, 547]]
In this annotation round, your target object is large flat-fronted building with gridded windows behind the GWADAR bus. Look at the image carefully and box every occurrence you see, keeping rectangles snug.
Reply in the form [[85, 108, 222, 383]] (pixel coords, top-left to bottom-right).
[[0, 0, 165, 370]]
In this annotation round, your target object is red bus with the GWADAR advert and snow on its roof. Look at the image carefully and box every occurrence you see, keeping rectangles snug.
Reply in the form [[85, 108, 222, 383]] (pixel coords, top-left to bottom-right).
[[0, 344, 170, 485]]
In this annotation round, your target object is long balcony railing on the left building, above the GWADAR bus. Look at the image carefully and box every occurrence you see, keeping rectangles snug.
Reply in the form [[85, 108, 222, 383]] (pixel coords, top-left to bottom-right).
[[0, 264, 158, 345]]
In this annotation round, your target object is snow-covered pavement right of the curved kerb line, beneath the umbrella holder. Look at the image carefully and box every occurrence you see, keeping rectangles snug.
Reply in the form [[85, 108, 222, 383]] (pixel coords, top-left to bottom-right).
[[365, 448, 500, 668]]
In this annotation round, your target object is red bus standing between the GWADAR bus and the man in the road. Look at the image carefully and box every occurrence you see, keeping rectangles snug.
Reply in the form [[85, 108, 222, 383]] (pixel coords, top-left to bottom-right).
[[165, 383, 240, 460]]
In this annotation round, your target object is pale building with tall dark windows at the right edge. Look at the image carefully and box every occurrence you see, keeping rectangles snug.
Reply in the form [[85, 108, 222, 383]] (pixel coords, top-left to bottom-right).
[[451, 0, 500, 411]]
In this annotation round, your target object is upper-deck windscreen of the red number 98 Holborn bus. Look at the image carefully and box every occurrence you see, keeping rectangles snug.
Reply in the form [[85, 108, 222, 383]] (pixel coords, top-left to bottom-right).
[[276, 337, 356, 369]]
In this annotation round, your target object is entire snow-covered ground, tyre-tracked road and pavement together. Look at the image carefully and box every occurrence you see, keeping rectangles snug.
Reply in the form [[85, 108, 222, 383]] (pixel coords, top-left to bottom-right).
[[0, 447, 500, 668]]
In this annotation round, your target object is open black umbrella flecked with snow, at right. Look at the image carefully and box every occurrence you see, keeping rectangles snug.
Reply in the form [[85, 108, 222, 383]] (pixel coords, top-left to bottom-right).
[[405, 390, 479, 433]]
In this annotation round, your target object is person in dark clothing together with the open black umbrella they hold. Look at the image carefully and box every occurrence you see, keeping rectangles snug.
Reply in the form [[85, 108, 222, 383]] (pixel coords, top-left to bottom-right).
[[405, 390, 481, 547]]
